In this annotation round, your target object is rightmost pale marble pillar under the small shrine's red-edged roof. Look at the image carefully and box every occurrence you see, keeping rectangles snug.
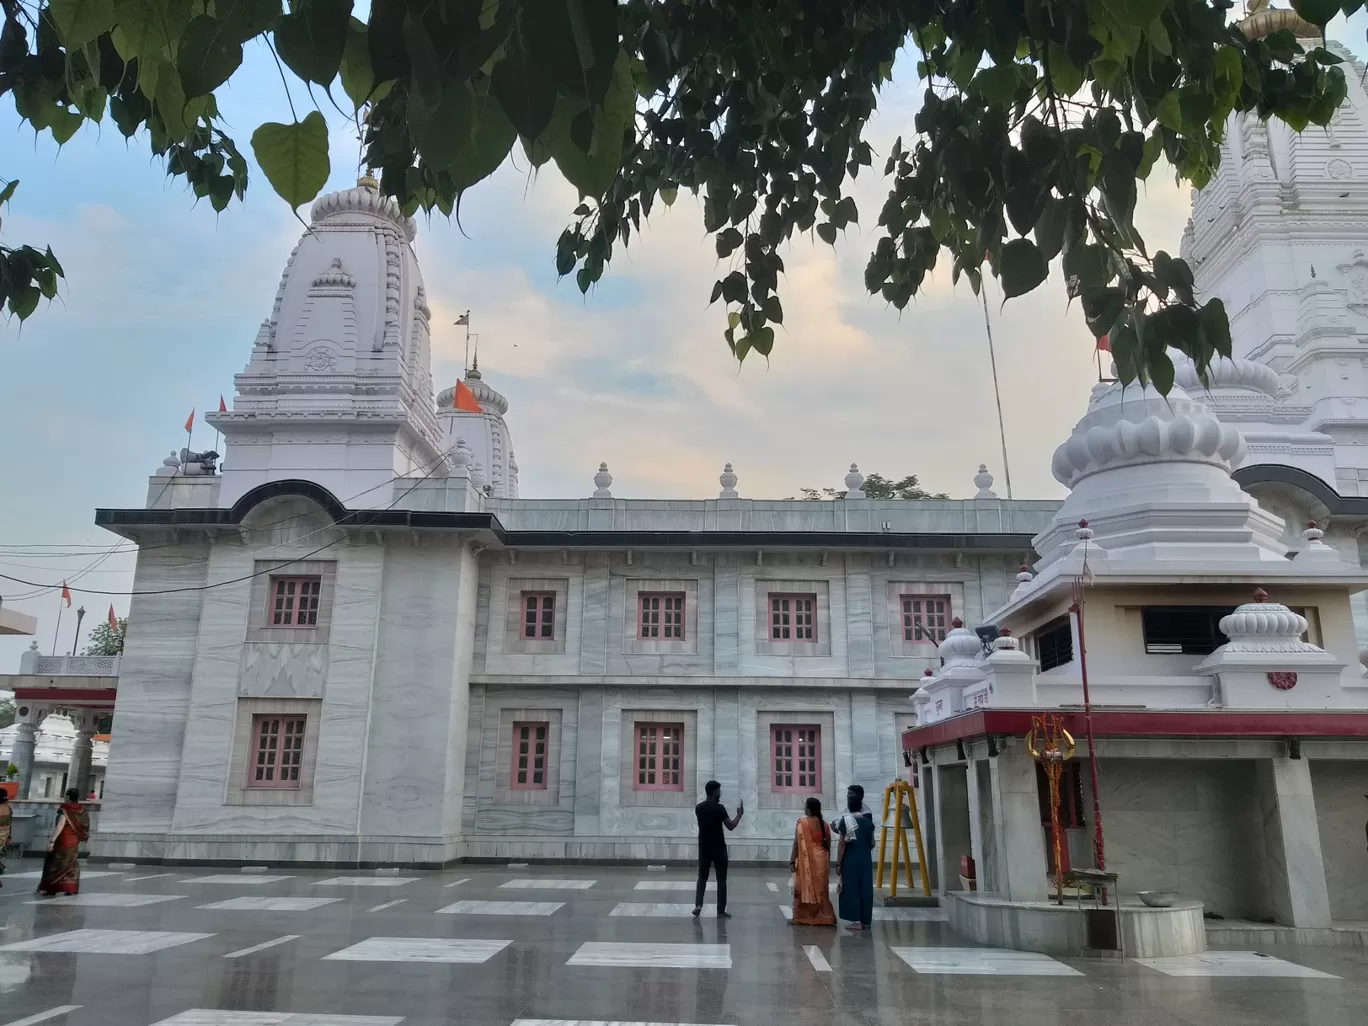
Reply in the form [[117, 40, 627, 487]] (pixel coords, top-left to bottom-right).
[[1257, 758, 1330, 926]]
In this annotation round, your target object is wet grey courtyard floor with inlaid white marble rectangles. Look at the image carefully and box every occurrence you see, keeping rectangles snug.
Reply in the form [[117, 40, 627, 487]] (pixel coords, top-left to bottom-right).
[[0, 863, 1368, 1026]]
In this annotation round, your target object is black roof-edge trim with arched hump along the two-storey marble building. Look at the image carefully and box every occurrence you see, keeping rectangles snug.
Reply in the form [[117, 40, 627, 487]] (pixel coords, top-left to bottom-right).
[[94, 480, 1033, 551]]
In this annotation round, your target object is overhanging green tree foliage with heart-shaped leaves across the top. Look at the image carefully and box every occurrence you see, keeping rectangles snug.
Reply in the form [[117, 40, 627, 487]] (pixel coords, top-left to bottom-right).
[[0, 0, 1364, 391]]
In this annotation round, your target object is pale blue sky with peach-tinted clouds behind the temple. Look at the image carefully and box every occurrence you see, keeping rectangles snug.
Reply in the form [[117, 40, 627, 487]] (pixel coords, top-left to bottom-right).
[[0, 14, 1368, 673]]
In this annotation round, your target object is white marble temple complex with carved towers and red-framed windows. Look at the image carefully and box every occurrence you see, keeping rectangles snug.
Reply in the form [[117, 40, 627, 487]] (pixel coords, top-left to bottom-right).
[[4, 32, 1368, 955]]
